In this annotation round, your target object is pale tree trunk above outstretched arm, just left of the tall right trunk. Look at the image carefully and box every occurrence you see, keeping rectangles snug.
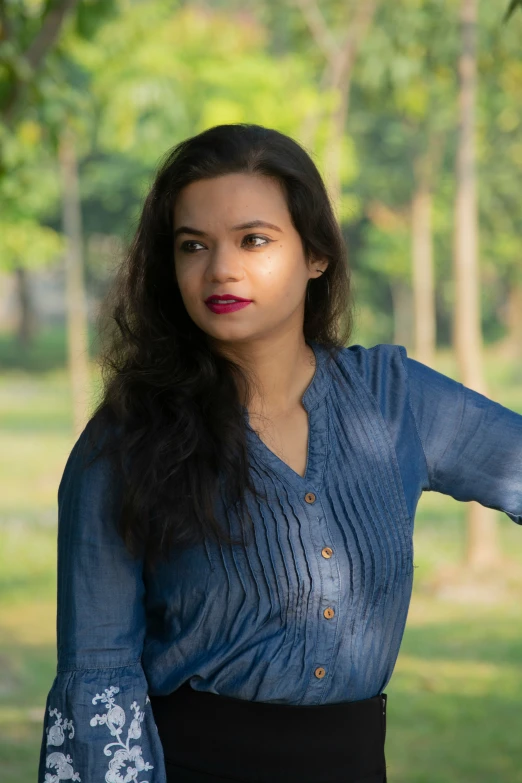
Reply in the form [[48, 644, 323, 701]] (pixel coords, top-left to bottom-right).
[[411, 178, 436, 366]]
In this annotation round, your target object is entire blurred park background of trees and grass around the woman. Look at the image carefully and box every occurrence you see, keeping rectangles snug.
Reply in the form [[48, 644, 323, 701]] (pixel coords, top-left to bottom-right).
[[0, 0, 522, 783]]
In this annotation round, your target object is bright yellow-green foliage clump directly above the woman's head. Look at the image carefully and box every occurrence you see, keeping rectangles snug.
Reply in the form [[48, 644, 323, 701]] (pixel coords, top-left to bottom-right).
[[71, 2, 317, 167]]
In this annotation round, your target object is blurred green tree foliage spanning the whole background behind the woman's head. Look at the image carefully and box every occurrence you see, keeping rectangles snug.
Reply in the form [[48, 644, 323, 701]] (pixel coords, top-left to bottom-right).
[[0, 0, 522, 346]]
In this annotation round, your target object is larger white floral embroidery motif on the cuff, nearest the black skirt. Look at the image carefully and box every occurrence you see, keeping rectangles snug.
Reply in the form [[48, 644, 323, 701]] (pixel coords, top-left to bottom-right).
[[91, 685, 154, 783]]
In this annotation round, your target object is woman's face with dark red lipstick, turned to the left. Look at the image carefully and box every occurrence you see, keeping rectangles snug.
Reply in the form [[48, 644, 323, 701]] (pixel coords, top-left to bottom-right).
[[174, 173, 327, 343]]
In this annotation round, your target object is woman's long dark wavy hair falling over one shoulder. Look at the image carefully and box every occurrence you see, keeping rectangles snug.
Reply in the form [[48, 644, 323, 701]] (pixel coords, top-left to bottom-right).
[[88, 124, 353, 567]]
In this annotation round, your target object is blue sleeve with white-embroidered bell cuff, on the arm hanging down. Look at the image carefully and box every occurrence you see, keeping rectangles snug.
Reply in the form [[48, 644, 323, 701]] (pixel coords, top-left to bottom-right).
[[38, 423, 166, 783]]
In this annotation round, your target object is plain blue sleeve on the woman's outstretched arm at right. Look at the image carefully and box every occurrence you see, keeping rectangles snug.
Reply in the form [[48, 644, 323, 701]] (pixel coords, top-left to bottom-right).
[[400, 346, 522, 525]]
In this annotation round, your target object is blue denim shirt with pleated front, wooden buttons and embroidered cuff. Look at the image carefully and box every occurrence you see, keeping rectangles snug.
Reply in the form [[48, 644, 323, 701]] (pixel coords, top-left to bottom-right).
[[38, 342, 522, 783]]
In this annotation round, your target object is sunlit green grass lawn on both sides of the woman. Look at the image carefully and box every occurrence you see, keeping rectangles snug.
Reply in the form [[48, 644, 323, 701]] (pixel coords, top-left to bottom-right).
[[0, 342, 522, 783]]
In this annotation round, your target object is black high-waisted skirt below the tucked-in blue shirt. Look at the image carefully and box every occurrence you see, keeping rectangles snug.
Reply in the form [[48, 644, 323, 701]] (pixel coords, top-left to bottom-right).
[[150, 681, 387, 783]]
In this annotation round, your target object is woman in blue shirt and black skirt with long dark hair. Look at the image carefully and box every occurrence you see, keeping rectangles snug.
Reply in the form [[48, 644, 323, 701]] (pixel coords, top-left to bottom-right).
[[39, 125, 522, 783]]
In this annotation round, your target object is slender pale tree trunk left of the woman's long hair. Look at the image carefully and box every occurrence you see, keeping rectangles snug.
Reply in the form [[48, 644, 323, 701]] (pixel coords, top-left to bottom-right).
[[59, 125, 90, 437]]
